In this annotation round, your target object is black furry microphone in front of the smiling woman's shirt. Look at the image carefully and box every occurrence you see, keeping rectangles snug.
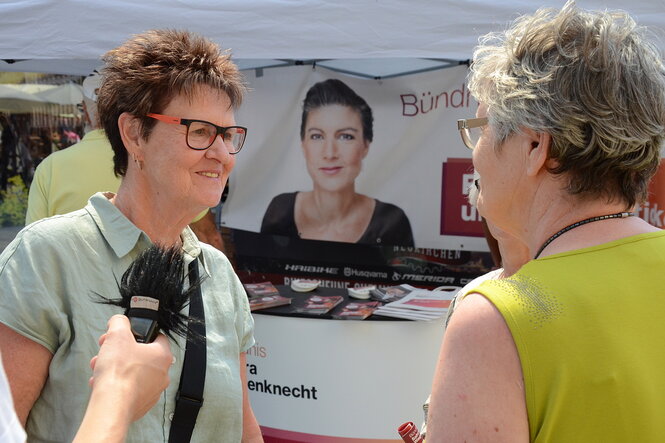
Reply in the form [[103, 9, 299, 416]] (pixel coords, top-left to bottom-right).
[[102, 245, 201, 343]]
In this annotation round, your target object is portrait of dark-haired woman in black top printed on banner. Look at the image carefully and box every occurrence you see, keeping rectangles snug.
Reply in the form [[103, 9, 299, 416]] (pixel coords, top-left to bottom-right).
[[261, 79, 413, 246]]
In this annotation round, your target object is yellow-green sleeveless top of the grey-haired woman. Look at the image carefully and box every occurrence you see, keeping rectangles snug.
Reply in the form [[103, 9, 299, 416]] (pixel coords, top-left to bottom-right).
[[474, 231, 665, 443]]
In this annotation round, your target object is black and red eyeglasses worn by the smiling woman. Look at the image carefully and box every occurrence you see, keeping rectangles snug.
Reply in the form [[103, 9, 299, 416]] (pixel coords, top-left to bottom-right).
[[146, 113, 247, 154]]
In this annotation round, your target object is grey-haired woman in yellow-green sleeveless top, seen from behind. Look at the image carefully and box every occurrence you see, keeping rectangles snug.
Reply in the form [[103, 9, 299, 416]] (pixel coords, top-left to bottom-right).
[[427, 3, 665, 443]]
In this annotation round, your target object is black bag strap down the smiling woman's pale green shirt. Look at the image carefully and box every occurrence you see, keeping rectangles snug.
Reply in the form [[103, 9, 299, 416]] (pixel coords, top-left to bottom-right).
[[169, 258, 206, 443]]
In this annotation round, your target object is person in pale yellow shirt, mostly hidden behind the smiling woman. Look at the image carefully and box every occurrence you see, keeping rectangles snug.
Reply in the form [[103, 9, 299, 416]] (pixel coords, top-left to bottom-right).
[[25, 72, 224, 251]]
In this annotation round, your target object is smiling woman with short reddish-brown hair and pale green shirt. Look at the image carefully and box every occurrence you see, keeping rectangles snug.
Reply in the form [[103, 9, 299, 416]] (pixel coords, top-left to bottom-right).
[[0, 31, 261, 442]]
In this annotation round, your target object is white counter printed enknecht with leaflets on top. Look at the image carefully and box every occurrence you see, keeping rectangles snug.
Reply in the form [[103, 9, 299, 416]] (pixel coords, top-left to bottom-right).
[[247, 286, 443, 443]]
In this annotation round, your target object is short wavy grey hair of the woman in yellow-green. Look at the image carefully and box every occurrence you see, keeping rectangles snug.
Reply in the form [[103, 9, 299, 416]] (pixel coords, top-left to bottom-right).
[[469, 2, 665, 208]]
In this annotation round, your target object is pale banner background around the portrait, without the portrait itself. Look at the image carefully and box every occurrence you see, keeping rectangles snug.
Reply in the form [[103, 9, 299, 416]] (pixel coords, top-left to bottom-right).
[[222, 66, 480, 251]]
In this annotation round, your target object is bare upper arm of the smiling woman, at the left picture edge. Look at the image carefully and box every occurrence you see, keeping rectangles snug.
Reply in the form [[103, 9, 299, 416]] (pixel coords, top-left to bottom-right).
[[0, 324, 53, 427]]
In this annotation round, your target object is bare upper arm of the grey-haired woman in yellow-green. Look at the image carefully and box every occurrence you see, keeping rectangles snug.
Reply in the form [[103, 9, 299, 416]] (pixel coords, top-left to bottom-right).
[[427, 294, 529, 443]]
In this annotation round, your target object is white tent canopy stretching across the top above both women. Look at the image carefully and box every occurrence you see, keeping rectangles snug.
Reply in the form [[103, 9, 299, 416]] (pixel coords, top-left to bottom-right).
[[0, 0, 665, 77]]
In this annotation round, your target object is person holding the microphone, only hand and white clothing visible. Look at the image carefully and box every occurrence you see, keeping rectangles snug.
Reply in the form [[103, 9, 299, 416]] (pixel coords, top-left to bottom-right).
[[0, 315, 173, 443]]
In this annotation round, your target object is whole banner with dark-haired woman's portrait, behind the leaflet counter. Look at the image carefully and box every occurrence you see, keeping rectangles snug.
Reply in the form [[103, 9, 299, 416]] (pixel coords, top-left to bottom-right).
[[222, 66, 492, 288]]
